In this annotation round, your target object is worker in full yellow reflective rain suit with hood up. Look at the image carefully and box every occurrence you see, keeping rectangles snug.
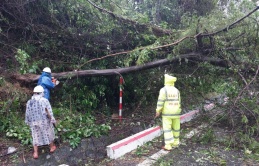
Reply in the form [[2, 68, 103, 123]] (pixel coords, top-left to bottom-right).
[[155, 74, 181, 150]]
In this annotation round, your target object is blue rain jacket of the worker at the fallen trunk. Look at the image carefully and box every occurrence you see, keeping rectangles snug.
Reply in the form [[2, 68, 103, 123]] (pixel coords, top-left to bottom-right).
[[38, 72, 55, 100]]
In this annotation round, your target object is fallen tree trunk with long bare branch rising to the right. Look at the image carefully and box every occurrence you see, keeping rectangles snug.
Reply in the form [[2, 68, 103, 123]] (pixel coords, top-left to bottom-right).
[[12, 4, 259, 83]]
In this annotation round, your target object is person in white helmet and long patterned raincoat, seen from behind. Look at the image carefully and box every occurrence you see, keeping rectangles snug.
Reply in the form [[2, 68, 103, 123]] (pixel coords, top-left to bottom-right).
[[25, 85, 56, 159]]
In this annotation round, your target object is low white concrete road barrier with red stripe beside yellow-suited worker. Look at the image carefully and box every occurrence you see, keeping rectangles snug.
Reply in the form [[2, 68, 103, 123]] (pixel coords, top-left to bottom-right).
[[106, 110, 199, 159]]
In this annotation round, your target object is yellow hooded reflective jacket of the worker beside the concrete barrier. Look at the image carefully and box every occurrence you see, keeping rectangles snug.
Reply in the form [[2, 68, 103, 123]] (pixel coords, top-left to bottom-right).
[[156, 74, 181, 118]]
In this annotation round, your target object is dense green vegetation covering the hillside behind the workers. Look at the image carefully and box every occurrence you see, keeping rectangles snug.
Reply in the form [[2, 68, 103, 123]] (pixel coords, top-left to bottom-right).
[[0, 0, 259, 158]]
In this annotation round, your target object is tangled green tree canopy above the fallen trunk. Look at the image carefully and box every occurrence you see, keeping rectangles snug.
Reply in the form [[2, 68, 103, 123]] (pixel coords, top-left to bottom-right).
[[1, 0, 258, 80]]
